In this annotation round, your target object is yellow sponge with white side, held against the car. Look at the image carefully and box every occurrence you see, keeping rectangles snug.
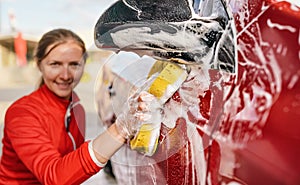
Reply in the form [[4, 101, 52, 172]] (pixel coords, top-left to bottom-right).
[[130, 61, 187, 156]]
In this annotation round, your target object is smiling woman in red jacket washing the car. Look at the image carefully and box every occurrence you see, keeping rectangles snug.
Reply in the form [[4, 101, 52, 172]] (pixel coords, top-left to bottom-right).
[[0, 29, 161, 184]]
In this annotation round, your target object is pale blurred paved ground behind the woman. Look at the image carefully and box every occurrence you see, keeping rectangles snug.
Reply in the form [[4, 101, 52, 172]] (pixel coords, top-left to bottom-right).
[[0, 63, 117, 185]]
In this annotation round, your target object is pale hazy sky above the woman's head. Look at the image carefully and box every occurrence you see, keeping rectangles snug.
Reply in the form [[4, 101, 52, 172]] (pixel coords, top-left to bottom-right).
[[0, 0, 300, 46]]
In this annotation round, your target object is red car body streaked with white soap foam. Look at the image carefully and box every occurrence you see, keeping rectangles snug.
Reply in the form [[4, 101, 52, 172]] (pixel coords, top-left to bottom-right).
[[97, 0, 300, 185]]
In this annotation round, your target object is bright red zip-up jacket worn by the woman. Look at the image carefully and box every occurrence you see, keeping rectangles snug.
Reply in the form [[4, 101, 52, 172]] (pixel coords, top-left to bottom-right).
[[0, 85, 100, 185]]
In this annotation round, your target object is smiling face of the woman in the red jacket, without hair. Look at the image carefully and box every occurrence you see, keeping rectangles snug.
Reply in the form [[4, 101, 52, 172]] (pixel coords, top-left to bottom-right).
[[39, 40, 85, 99]]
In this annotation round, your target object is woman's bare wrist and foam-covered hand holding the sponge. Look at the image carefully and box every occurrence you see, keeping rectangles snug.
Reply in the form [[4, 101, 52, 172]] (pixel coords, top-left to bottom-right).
[[91, 91, 162, 164]]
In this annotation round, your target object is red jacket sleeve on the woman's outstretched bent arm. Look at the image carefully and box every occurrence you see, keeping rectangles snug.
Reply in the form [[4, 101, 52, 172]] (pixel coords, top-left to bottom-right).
[[5, 107, 100, 185]]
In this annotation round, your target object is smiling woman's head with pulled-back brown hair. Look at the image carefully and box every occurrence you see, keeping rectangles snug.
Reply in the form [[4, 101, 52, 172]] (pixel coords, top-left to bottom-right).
[[36, 29, 87, 99]]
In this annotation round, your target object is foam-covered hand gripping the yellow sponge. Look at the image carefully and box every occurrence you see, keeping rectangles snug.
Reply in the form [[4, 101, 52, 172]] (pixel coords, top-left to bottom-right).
[[116, 91, 162, 139]]
